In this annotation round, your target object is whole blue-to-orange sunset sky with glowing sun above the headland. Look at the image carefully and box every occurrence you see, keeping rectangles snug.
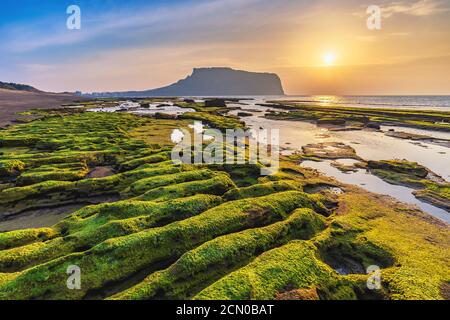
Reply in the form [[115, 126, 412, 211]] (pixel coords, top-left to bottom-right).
[[0, 0, 450, 95]]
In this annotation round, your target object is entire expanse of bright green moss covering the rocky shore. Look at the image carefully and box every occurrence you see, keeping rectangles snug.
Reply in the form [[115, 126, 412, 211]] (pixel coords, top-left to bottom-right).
[[0, 99, 450, 299]]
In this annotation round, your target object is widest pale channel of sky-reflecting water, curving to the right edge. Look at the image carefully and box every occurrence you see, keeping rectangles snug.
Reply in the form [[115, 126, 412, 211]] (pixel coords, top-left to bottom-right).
[[230, 100, 450, 181]]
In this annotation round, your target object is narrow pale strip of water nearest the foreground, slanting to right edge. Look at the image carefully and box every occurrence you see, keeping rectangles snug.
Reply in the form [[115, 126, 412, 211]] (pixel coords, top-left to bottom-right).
[[301, 160, 450, 223]]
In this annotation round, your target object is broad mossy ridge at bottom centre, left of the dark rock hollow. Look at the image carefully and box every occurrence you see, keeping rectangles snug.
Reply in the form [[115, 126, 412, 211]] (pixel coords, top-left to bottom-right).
[[195, 240, 344, 300]]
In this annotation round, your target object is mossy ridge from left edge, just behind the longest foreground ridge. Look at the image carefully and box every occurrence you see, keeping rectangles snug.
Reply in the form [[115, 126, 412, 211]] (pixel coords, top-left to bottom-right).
[[0, 195, 221, 272]]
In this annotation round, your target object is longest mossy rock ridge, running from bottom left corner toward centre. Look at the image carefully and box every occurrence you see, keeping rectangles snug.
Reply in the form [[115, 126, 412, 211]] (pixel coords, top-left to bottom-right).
[[0, 191, 324, 299]]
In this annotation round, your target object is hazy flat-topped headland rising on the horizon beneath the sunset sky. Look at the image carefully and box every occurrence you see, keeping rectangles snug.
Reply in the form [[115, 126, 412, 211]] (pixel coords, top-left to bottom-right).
[[88, 68, 284, 97]]
